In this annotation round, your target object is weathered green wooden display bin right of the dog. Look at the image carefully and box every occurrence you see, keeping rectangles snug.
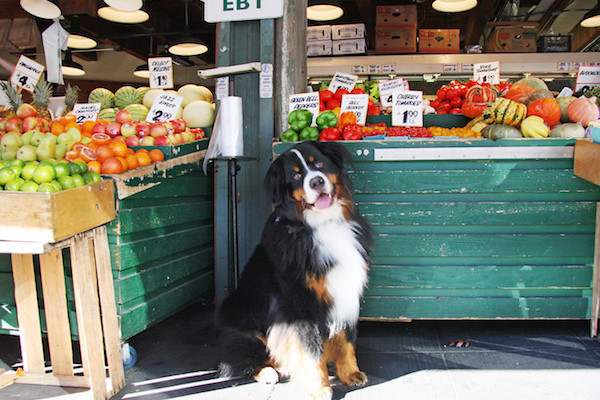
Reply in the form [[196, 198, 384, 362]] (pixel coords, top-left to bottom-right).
[[274, 139, 600, 320]]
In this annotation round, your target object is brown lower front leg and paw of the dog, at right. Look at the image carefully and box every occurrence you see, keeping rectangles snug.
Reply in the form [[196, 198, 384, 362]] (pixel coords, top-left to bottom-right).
[[323, 332, 367, 386]]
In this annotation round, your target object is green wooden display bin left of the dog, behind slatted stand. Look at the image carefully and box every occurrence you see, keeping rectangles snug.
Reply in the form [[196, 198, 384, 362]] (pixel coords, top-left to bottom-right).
[[0, 151, 214, 340]]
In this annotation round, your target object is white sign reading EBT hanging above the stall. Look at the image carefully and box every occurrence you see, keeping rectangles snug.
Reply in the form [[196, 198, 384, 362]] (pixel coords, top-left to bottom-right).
[[204, 0, 284, 22]]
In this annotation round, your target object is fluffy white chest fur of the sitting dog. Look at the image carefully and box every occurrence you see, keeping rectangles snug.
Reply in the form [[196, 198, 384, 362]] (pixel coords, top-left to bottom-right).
[[314, 211, 368, 335]]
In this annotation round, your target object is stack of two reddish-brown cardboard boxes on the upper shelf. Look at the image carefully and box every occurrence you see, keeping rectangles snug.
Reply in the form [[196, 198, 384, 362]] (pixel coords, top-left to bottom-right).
[[375, 4, 417, 53]]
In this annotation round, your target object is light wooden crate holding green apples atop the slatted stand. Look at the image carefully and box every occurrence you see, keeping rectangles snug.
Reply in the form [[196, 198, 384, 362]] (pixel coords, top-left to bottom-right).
[[0, 179, 115, 243]]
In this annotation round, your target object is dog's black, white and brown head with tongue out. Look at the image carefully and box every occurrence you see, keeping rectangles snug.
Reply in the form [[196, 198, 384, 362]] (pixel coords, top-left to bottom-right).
[[265, 141, 353, 222]]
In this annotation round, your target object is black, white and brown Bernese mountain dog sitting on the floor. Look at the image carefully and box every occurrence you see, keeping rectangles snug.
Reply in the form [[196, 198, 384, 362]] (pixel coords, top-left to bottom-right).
[[216, 141, 372, 400]]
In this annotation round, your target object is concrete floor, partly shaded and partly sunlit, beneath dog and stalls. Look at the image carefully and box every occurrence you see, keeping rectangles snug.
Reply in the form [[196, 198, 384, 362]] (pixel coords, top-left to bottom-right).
[[0, 305, 600, 400]]
